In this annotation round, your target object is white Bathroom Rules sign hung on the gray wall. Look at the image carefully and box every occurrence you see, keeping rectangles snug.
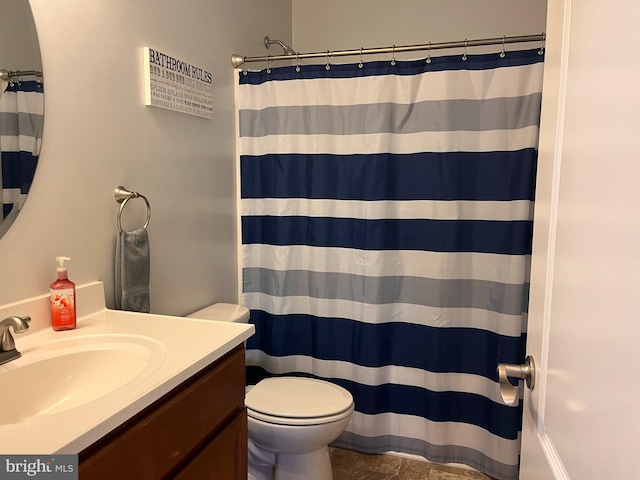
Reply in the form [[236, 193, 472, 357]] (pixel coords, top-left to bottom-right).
[[143, 47, 213, 118]]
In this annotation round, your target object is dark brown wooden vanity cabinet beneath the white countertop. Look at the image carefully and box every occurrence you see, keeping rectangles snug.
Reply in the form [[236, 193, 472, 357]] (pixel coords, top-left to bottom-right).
[[79, 345, 247, 480]]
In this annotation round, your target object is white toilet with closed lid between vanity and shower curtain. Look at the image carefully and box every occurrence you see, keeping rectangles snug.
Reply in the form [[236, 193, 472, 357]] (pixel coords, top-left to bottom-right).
[[189, 303, 353, 480]]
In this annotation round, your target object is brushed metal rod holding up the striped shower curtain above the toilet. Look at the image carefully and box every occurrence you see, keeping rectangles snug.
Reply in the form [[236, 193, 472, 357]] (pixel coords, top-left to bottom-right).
[[231, 33, 546, 68]]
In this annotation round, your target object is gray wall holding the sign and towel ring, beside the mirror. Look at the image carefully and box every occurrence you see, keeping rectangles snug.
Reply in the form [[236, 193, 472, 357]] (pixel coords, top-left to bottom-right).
[[0, 0, 292, 314]]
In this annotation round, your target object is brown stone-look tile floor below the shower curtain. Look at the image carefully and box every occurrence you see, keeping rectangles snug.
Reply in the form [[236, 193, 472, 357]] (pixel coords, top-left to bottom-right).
[[329, 447, 492, 480]]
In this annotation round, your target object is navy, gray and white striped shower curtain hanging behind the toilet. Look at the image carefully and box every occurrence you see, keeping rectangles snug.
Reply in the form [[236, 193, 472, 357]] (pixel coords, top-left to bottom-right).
[[238, 46, 543, 479]]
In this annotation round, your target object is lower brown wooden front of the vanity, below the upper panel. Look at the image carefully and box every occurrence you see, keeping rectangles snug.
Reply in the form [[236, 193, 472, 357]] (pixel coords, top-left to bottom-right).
[[175, 412, 247, 480]]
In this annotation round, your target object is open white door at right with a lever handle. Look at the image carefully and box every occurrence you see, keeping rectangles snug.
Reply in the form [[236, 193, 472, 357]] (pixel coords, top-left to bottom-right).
[[520, 0, 640, 480]]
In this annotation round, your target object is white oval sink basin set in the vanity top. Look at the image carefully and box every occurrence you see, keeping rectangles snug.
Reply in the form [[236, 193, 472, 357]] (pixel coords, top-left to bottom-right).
[[0, 335, 164, 425]]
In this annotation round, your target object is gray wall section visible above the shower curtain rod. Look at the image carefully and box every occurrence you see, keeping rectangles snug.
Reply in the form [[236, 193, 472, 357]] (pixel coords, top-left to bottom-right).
[[293, 0, 547, 57]]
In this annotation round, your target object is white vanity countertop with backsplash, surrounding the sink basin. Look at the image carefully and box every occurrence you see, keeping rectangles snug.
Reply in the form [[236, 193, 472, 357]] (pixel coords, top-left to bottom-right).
[[0, 282, 254, 454]]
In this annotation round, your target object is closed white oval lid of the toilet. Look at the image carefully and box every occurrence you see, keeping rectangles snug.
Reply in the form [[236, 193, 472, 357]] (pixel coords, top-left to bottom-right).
[[245, 377, 353, 418]]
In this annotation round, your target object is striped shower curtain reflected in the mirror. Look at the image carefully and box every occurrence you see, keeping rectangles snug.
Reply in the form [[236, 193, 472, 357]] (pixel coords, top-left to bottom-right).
[[0, 80, 44, 221]]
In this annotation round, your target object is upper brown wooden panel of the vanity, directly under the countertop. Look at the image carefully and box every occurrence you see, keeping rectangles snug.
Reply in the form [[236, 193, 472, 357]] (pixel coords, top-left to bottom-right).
[[80, 347, 246, 480]]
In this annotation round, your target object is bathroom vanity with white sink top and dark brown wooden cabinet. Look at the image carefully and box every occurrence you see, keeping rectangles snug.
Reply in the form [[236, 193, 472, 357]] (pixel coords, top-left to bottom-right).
[[0, 282, 254, 480]]
